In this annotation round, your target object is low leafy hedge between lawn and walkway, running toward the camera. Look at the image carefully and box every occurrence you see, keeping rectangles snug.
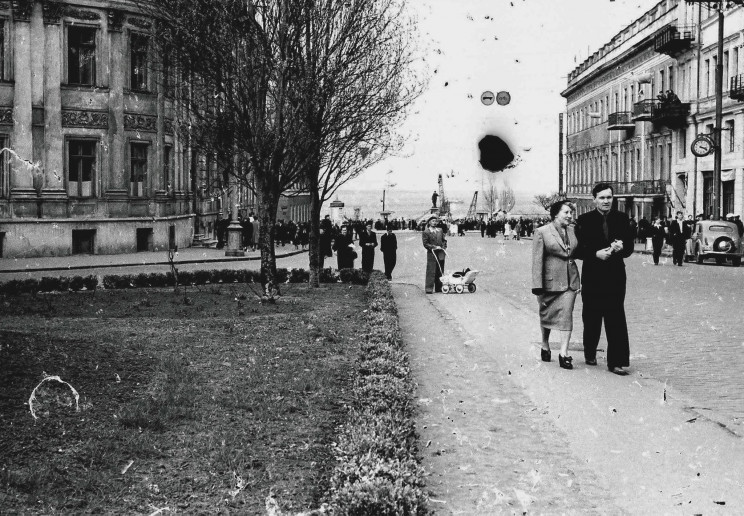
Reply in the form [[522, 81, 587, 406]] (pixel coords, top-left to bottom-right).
[[328, 271, 429, 516]]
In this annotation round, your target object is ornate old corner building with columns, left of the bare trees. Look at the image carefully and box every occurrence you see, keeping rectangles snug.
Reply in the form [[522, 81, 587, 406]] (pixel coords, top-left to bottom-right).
[[0, 0, 208, 258]]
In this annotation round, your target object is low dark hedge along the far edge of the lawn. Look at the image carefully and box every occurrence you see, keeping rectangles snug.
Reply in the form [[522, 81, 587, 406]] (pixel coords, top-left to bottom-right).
[[0, 268, 369, 295]]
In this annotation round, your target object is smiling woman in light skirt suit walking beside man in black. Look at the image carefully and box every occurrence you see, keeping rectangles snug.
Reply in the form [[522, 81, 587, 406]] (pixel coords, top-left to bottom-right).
[[532, 201, 581, 369]]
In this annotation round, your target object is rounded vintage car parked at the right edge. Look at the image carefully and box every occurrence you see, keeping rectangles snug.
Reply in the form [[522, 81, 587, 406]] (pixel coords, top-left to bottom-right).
[[685, 220, 744, 267]]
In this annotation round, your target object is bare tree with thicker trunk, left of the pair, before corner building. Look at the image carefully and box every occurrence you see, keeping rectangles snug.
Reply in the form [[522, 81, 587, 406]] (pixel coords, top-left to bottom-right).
[[138, 0, 322, 300]]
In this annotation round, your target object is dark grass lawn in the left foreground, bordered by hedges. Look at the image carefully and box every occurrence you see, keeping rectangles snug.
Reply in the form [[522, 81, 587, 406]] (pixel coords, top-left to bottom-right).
[[0, 283, 366, 514]]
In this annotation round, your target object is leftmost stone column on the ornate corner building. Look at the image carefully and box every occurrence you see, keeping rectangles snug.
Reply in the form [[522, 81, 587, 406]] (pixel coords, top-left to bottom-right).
[[10, 2, 33, 193]]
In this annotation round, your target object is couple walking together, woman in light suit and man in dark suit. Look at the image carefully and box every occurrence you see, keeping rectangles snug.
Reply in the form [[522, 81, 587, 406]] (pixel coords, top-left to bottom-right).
[[532, 183, 633, 375]]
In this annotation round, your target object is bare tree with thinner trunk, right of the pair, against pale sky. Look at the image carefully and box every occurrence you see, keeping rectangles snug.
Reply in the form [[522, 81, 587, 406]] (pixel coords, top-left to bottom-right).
[[296, 0, 421, 286]]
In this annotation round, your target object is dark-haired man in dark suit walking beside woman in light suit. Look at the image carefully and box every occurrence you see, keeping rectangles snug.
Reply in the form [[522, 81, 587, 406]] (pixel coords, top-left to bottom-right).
[[576, 183, 633, 375]]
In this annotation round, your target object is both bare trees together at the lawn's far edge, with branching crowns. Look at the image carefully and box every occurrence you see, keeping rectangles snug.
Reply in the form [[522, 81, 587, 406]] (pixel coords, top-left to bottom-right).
[[139, 0, 422, 299]]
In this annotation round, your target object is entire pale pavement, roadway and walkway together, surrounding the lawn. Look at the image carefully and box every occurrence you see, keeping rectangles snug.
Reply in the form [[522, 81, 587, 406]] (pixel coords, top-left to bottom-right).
[[0, 232, 744, 514]]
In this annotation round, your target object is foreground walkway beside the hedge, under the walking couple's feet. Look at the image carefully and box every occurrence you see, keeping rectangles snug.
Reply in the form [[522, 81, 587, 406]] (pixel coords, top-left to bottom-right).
[[393, 284, 744, 515]]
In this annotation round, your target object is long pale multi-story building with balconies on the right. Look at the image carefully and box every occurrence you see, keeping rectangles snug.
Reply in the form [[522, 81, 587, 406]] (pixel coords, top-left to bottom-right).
[[561, 0, 744, 220]]
